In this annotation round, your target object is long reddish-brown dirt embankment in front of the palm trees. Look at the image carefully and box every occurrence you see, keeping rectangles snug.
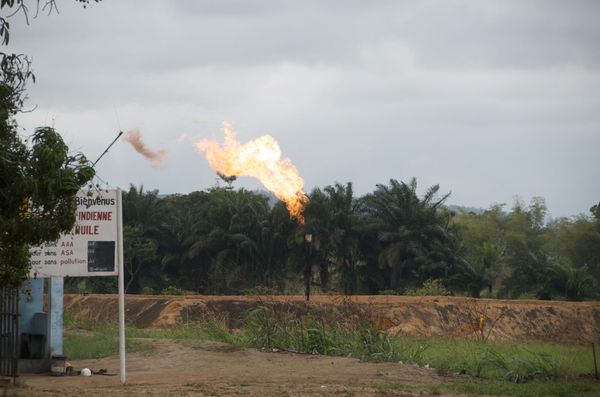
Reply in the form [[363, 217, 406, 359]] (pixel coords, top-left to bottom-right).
[[65, 294, 600, 344]]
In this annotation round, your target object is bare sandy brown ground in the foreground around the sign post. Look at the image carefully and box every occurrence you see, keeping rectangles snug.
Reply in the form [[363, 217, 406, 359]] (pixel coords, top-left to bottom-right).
[[18, 340, 450, 397]]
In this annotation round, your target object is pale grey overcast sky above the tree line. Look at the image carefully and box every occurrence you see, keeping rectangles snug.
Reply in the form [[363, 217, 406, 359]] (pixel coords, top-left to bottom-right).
[[5, 0, 600, 217]]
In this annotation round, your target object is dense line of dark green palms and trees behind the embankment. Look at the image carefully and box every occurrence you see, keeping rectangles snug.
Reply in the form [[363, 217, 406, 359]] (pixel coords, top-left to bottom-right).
[[68, 179, 600, 300]]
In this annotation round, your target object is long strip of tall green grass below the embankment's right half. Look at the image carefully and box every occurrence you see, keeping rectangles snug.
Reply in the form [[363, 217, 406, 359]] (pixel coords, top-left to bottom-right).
[[240, 306, 593, 382]]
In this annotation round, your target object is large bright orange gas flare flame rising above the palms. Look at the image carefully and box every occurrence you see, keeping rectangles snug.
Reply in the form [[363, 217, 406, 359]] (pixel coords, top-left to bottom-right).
[[195, 123, 308, 224]]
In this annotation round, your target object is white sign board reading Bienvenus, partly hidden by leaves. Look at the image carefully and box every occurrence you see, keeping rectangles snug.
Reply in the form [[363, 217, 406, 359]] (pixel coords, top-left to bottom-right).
[[29, 189, 122, 278]]
